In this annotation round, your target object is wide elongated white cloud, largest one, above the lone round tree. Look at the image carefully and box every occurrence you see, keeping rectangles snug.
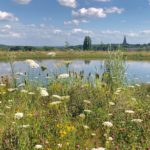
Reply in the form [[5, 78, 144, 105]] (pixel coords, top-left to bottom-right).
[[72, 7, 124, 18]]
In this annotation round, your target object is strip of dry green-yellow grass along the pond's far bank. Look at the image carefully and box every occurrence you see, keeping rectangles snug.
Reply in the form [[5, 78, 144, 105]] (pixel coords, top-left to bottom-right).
[[0, 50, 150, 61]]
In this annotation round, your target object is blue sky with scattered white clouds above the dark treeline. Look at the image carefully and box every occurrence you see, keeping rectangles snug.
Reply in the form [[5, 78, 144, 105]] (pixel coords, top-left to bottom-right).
[[0, 0, 150, 46]]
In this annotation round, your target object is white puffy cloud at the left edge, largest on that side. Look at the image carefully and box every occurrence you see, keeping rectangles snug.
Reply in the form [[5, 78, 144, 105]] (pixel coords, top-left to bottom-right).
[[0, 11, 18, 21]]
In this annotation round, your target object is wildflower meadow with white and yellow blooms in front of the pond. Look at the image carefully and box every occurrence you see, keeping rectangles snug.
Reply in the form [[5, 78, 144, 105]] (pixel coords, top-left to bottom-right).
[[0, 50, 150, 150]]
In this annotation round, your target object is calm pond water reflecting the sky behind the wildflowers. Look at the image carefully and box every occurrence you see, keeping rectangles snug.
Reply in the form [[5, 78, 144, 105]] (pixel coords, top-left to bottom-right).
[[0, 60, 150, 83]]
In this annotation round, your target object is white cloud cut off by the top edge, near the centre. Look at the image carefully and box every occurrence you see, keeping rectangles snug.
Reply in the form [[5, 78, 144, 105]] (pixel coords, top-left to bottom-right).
[[58, 0, 77, 8]]
